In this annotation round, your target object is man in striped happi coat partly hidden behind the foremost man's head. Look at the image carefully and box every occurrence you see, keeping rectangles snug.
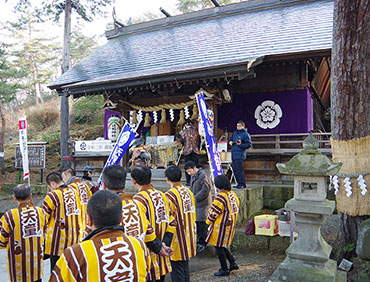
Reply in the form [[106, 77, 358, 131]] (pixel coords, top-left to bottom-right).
[[102, 165, 173, 256]]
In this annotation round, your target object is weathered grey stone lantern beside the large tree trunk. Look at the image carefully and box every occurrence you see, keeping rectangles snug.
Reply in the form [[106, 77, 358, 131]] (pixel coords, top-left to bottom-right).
[[270, 134, 346, 282]]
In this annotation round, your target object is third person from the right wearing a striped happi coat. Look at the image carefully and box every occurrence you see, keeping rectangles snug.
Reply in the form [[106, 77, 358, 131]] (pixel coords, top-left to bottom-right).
[[131, 165, 176, 281]]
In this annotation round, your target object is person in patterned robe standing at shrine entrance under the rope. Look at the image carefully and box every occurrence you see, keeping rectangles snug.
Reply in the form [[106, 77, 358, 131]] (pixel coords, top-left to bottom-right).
[[180, 120, 199, 186]]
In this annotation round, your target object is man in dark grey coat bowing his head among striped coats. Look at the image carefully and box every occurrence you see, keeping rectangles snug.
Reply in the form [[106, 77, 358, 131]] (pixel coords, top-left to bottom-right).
[[185, 161, 212, 253]]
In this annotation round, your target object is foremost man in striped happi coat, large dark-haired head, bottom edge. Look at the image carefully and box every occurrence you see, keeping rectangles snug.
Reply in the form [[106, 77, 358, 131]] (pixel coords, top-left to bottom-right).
[[49, 190, 150, 282]]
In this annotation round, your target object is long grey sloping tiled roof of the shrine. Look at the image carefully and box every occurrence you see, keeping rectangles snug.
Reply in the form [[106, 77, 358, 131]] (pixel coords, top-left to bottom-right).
[[49, 0, 334, 88]]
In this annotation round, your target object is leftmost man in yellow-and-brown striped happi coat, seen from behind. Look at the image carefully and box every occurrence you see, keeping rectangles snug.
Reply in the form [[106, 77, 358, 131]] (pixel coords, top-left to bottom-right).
[[0, 184, 45, 282]]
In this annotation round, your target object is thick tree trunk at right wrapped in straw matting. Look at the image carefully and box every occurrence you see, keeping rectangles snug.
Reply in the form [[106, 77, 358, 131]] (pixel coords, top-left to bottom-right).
[[331, 0, 370, 256]]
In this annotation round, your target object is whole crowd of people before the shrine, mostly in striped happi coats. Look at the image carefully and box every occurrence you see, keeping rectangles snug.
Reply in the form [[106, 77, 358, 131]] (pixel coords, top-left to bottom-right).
[[0, 120, 250, 282]]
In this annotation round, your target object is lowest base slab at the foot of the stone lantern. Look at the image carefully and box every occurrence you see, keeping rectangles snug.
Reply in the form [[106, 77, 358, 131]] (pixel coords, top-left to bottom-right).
[[269, 257, 347, 282]]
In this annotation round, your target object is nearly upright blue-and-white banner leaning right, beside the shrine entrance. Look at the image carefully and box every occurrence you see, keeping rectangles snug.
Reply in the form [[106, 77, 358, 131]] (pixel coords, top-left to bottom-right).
[[197, 92, 222, 177]]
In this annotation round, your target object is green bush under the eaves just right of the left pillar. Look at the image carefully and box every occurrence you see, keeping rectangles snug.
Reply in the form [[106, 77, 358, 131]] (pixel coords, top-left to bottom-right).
[[72, 95, 104, 124]]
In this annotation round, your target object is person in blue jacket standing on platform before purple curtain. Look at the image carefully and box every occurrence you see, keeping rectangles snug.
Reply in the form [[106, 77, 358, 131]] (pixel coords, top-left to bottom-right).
[[229, 120, 251, 189]]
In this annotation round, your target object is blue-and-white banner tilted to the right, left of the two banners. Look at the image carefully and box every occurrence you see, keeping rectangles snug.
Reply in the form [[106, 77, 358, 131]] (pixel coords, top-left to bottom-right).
[[98, 123, 136, 189]]
